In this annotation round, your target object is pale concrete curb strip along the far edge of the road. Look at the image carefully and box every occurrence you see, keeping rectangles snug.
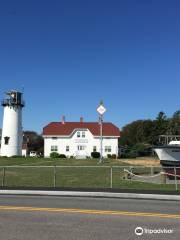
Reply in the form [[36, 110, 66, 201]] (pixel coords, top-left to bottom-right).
[[0, 190, 180, 201]]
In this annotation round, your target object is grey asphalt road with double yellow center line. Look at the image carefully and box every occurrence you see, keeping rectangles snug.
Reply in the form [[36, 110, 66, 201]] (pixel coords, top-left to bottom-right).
[[0, 195, 180, 240]]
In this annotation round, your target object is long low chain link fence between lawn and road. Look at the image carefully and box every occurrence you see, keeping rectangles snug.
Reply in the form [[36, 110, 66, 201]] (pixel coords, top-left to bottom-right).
[[0, 166, 180, 190]]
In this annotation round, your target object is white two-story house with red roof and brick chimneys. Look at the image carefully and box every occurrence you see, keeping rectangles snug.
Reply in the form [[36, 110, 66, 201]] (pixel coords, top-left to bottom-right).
[[43, 118, 120, 158]]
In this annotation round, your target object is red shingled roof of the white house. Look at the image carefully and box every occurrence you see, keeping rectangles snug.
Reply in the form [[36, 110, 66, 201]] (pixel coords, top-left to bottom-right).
[[43, 122, 120, 137]]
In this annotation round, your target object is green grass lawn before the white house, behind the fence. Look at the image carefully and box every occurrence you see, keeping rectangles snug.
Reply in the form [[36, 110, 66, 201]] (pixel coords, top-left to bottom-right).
[[0, 158, 180, 190]]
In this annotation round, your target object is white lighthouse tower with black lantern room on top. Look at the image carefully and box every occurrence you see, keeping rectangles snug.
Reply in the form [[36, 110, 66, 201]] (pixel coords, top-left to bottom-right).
[[1, 90, 24, 157]]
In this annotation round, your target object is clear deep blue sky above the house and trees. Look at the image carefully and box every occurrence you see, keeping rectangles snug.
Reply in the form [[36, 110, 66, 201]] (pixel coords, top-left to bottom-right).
[[0, 0, 180, 133]]
